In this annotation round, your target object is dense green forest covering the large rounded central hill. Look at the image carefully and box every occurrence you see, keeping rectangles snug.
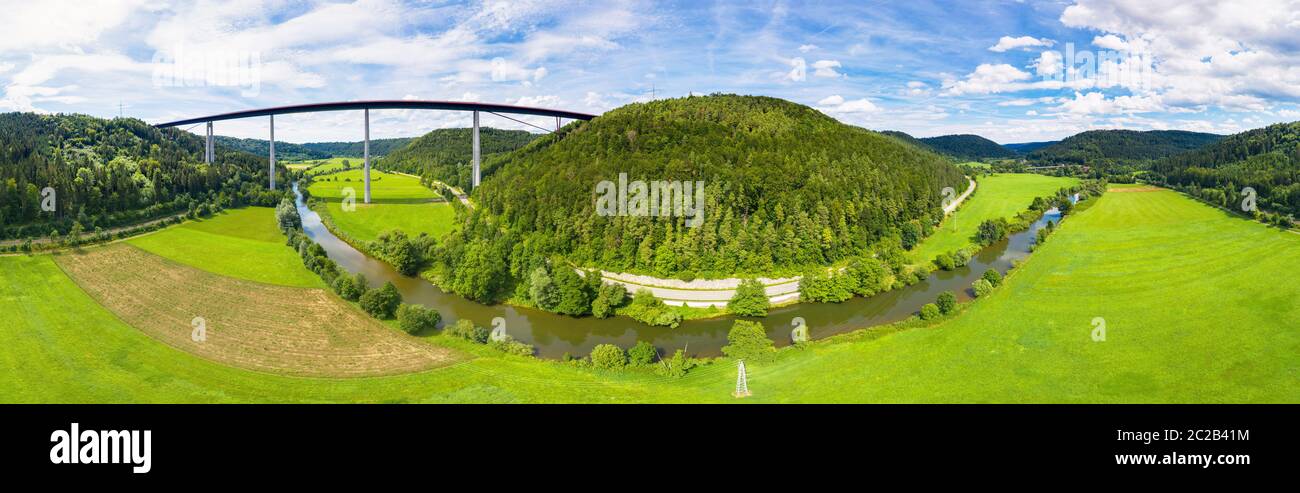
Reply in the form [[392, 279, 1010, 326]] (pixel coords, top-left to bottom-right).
[[434, 95, 965, 302]]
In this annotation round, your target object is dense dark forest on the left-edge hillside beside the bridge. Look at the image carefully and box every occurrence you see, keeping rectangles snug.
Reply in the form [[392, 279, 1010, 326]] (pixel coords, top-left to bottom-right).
[[0, 113, 285, 238]]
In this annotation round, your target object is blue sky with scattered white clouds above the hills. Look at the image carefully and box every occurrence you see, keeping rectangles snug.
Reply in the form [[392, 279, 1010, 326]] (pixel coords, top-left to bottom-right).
[[0, 0, 1300, 143]]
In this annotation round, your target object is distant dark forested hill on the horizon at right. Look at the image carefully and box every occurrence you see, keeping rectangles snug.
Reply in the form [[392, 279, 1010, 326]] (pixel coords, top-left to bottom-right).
[[1028, 130, 1223, 164]]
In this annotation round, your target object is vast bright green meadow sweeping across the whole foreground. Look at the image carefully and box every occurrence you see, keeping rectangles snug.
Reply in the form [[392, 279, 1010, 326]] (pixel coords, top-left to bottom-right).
[[0, 191, 1300, 402]]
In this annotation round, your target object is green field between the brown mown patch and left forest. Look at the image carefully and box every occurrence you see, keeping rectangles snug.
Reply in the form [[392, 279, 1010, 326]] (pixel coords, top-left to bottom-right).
[[129, 207, 324, 287]]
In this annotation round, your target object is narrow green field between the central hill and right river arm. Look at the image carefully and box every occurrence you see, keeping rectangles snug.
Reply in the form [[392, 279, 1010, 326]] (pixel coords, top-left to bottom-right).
[[909, 173, 1079, 264]]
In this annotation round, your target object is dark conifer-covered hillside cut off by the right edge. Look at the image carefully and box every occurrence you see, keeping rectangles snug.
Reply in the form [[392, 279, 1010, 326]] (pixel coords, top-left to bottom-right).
[[1151, 122, 1300, 216]]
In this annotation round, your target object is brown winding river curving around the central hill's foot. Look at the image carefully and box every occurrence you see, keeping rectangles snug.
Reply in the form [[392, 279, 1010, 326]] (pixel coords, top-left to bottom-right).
[[294, 183, 1061, 358]]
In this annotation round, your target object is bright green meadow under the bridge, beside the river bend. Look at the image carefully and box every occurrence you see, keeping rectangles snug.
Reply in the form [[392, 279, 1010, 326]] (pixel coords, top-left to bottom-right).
[[308, 169, 455, 242]]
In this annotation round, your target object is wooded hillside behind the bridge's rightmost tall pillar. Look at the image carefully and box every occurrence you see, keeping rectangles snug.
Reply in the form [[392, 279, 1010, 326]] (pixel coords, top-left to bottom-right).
[[378, 127, 540, 190]]
